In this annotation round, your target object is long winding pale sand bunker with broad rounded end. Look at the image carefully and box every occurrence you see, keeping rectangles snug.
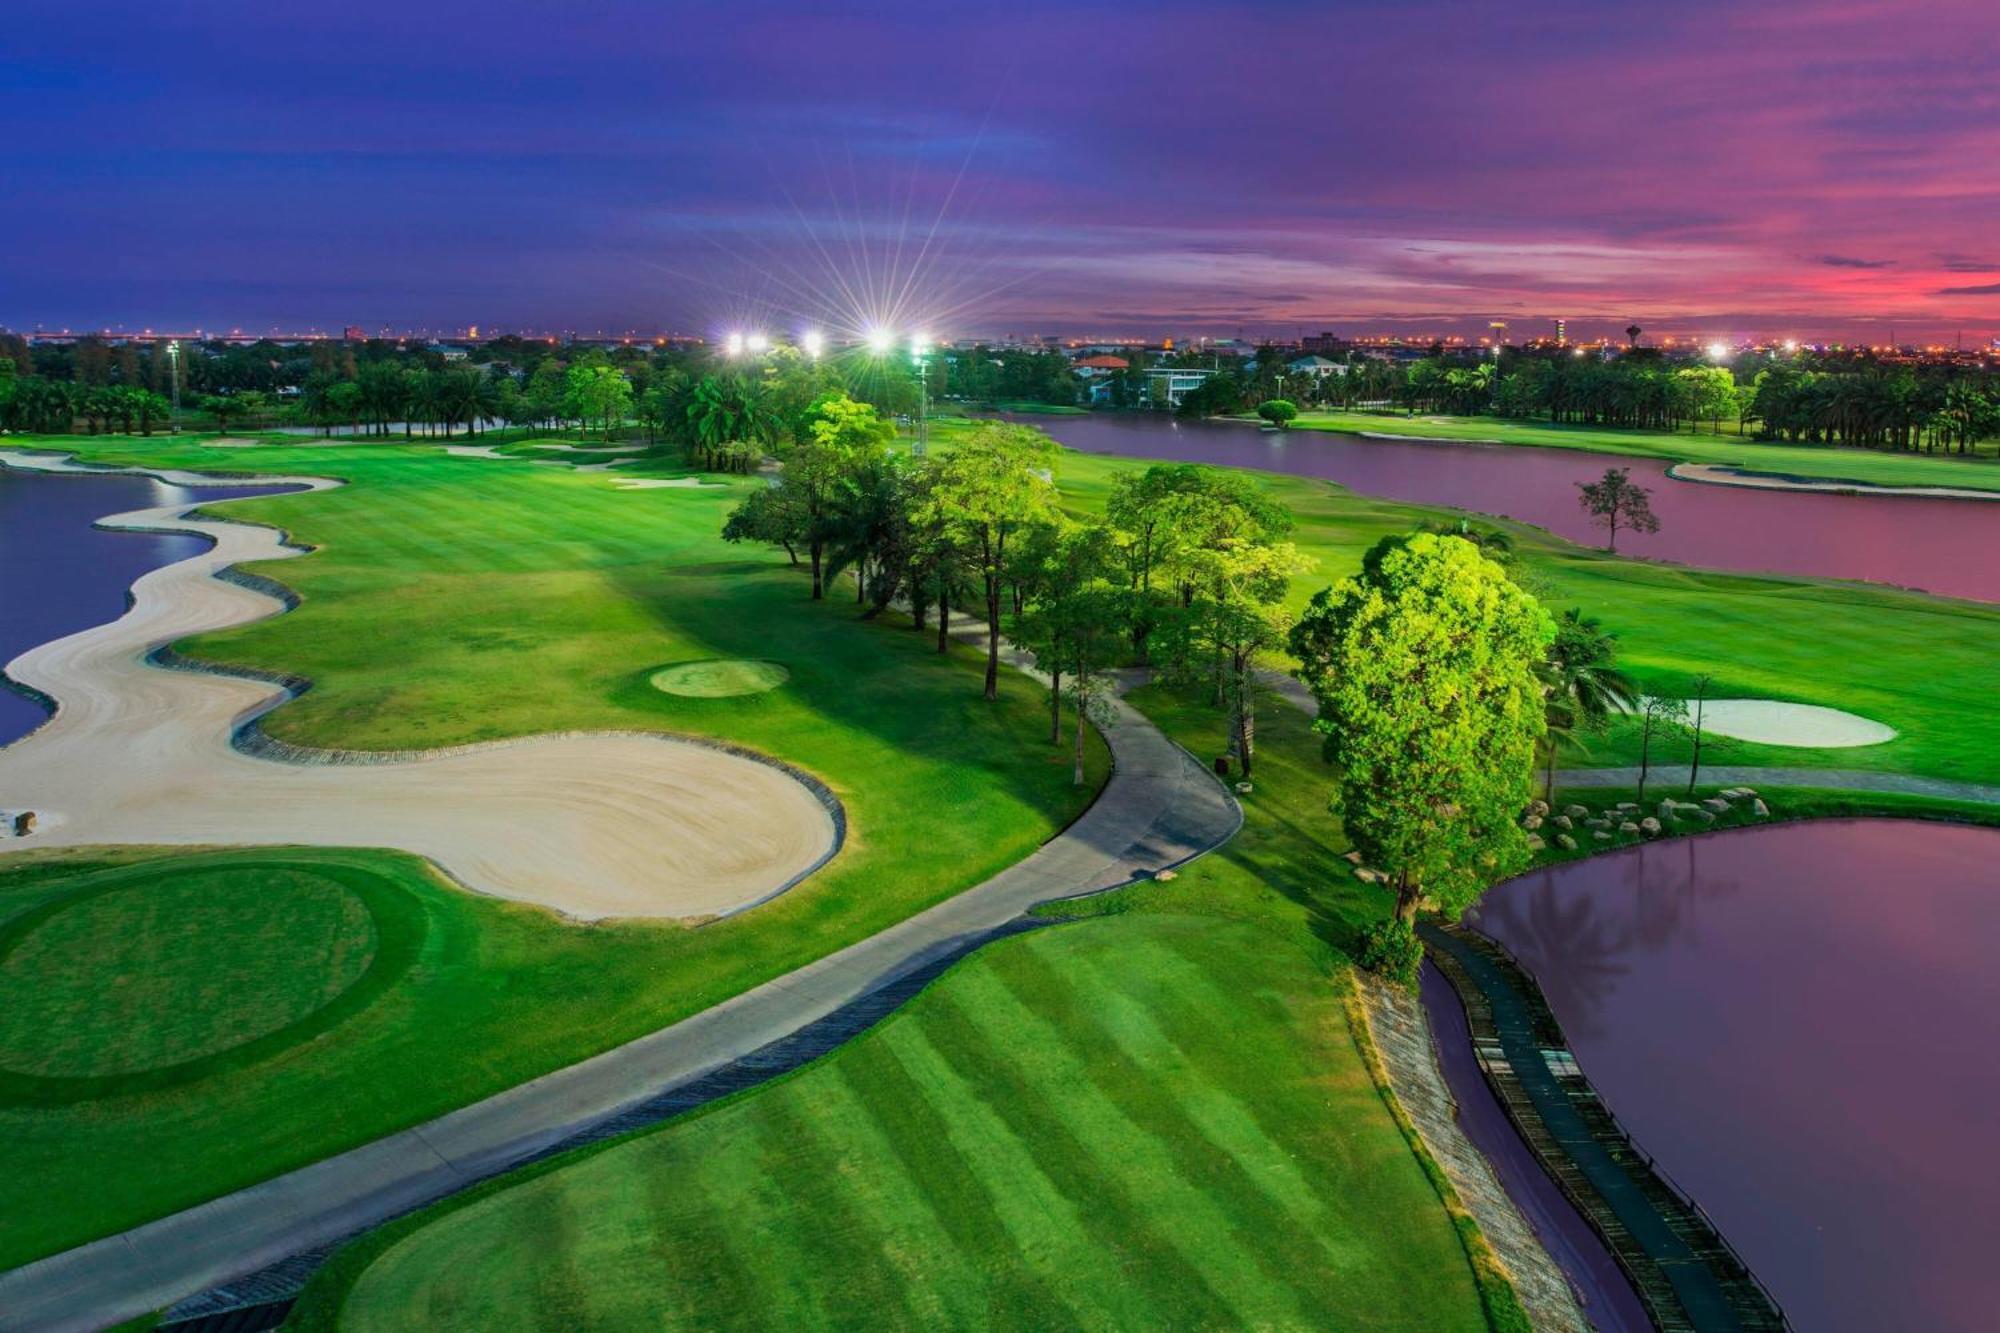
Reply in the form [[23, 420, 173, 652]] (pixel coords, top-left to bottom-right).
[[0, 450, 842, 919]]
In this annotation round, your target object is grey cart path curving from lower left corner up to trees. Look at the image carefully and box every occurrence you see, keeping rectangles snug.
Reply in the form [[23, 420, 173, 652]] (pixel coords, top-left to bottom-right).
[[0, 454, 1242, 1331]]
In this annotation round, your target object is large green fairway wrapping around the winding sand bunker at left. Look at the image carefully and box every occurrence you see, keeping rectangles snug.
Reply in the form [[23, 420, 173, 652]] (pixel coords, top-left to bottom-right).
[[0, 436, 1106, 1267]]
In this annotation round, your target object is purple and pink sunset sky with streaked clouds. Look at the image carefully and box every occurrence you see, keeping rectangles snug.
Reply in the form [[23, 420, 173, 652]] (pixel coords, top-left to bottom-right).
[[0, 0, 2000, 338]]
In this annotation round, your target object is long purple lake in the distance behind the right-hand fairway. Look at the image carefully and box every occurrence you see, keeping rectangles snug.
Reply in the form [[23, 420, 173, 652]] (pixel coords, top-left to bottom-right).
[[1022, 414, 2000, 602]]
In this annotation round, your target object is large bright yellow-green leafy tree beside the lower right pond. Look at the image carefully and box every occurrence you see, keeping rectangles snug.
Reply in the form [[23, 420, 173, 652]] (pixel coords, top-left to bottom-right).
[[1292, 532, 1556, 929]]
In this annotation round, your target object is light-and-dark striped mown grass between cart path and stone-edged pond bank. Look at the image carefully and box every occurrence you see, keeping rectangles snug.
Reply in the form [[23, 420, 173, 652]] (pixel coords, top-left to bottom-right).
[[294, 913, 1486, 1331]]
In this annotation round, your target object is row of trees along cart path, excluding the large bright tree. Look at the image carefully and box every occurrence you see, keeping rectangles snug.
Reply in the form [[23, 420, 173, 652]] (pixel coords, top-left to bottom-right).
[[724, 396, 1306, 781]]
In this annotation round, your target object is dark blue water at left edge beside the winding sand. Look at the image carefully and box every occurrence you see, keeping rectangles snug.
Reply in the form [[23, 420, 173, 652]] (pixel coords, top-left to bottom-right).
[[0, 468, 282, 745]]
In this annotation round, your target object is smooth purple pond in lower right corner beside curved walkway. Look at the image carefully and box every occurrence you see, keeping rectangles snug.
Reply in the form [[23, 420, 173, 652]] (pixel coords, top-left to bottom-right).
[[1472, 821, 2000, 1329]]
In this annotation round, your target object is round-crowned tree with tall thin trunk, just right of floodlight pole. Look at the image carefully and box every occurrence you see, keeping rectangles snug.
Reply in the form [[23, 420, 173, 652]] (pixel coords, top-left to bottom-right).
[[924, 420, 1056, 699]]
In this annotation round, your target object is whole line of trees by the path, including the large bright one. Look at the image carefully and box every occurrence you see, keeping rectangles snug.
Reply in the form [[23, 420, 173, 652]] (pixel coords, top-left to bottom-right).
[[724, 396, 1636, 971]]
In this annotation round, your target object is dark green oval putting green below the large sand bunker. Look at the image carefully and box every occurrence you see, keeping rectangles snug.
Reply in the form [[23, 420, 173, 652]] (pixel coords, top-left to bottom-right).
[[0, 865, 380, 1097]]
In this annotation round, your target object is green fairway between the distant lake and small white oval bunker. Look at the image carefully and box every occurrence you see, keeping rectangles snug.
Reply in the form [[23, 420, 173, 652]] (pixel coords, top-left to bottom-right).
[[1062, 452, 2000, 783]]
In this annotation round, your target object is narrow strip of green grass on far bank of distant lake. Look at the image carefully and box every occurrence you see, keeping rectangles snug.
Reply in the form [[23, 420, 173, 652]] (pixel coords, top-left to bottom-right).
[[1292, 410, 2000, 490]]
